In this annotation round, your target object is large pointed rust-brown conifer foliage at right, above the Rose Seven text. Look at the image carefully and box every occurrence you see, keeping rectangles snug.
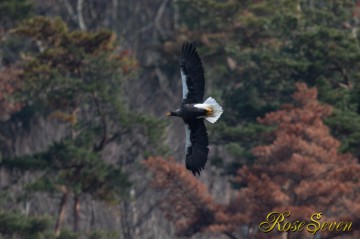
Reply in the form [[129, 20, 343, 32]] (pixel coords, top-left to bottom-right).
[[237, 84, 360, 237]]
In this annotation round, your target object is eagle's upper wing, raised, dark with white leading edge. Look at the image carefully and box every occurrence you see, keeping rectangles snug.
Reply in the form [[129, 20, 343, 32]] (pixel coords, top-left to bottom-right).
[[180, 43, 205, 104]]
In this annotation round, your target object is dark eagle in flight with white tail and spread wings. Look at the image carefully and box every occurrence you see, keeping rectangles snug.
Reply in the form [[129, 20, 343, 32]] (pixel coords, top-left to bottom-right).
[[166, 43, 223, 175]]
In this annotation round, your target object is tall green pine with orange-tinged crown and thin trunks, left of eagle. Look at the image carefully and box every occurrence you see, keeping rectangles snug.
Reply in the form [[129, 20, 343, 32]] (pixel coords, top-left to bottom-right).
[[1, 17, 162, 236]]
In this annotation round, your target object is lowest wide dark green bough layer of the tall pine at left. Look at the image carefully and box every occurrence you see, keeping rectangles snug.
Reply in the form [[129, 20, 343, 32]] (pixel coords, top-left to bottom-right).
[[1, 140, 130, 202]]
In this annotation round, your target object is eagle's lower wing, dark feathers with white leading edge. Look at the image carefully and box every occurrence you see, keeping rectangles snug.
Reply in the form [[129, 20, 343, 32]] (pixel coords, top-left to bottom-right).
[[184, 119, 209, 175]]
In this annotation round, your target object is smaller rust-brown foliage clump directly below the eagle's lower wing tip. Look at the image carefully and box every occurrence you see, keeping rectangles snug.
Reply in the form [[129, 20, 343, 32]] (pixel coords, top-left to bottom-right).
[[144, 157, 245, 236]]
